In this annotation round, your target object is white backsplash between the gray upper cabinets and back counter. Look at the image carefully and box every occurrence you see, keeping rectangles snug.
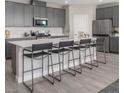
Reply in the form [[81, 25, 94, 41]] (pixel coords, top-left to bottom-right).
[[5, 27, 63, 38]]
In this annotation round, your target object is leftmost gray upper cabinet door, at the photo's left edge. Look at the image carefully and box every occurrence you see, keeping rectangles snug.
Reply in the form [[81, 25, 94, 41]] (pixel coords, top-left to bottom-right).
[[5, 2, 14, 26]]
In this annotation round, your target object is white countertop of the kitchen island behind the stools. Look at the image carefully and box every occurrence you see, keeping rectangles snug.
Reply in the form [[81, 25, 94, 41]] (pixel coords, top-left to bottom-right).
[[9, 37, 96, 48]]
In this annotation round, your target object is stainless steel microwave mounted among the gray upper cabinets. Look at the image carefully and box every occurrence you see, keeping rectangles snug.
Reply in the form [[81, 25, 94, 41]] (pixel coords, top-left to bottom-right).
[[33, 18, 48, 27]]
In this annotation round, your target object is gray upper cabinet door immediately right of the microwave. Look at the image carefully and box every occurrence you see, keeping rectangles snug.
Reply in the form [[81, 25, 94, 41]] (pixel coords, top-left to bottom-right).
[[47, 8, 54, 27]]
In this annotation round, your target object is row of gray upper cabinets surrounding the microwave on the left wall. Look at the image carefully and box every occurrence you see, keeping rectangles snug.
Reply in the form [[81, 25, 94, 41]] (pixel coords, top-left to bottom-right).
[[5, 1, 65, 27]]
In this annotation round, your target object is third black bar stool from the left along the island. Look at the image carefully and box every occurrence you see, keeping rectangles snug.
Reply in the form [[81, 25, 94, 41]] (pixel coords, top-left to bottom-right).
[[74, 39, 92, 70]]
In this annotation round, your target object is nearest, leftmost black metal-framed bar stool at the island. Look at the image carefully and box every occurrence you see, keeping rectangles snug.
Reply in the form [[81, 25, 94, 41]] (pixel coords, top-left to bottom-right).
[[22, 43, 54, 93]]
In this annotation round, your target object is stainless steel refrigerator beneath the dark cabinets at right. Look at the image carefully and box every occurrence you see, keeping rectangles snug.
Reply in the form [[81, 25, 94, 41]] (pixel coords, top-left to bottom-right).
[[92, 19, 113, 52]]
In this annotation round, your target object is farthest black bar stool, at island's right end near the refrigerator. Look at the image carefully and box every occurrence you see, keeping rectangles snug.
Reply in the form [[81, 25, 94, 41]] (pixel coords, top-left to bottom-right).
[[90, 37, 106, 67]]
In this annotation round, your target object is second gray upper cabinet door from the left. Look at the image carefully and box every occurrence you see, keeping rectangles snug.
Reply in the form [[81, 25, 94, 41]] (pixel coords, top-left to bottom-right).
[[14, 3, 24, 26]]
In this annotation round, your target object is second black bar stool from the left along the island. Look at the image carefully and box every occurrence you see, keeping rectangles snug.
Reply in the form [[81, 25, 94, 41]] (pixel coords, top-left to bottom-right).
[[52, 40, 76, 81]]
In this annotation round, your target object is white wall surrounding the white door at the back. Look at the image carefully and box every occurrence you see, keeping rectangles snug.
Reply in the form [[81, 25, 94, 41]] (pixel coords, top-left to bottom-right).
[[66, 5, 96, 37]]
